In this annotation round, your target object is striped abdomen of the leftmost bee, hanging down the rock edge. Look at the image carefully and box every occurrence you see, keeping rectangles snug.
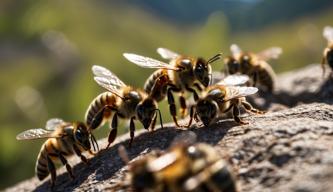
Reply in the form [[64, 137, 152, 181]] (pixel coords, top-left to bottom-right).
[[35, 138, 74, 180]]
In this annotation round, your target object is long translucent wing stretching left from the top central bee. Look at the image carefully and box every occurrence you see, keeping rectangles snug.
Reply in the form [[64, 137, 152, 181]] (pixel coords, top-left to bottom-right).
[[123, 53, 179, 71]]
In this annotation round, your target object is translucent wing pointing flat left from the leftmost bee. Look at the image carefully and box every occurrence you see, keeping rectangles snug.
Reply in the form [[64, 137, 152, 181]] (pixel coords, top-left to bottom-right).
[[16, 128, 61, 140]]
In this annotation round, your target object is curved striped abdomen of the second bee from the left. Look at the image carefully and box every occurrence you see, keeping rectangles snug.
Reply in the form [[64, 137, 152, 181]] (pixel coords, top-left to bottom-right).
[[85, 92, 116, 126]]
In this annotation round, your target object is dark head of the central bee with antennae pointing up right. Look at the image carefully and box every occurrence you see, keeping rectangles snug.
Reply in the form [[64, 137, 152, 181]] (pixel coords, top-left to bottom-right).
[[194, 58, 212, 87]]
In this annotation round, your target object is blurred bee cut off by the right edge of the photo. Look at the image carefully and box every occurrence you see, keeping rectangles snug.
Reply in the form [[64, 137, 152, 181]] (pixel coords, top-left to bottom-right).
[[321, 26, 333, 75]]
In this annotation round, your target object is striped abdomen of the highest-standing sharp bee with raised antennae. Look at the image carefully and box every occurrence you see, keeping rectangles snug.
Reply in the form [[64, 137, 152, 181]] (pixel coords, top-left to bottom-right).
[[144, 69, 170, 102]]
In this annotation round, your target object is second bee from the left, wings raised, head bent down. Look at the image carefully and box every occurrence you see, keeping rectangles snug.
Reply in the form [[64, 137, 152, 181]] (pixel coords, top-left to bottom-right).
[[86, 65, 163, 148]]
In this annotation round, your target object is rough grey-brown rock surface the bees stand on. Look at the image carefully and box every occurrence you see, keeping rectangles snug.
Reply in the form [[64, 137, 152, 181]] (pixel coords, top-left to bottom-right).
[[7, 65, 333, 191]]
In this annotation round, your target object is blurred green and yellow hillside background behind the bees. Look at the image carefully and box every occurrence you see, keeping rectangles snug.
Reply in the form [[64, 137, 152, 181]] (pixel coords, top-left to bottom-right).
[[0, 0, 333, 189]]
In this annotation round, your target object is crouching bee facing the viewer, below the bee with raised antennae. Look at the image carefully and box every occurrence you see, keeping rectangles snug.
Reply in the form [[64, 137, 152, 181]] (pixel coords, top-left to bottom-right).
[[188, 76, 264, 126]]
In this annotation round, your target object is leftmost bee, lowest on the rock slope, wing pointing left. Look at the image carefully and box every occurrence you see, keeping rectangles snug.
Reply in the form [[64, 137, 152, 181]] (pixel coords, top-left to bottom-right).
[[16, 118, 97, 187]]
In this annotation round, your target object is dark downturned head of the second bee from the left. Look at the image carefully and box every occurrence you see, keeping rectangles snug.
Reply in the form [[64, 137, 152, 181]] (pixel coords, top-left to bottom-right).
[[136, 98, 158, 129]]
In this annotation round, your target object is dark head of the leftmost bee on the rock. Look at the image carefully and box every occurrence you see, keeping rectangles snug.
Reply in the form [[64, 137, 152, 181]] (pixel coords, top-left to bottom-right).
[[74, 122, 91, 150]]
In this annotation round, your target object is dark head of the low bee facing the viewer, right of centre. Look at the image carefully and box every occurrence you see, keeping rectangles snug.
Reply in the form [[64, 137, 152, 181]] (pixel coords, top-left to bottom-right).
[[196, 99, 218, 126]]
